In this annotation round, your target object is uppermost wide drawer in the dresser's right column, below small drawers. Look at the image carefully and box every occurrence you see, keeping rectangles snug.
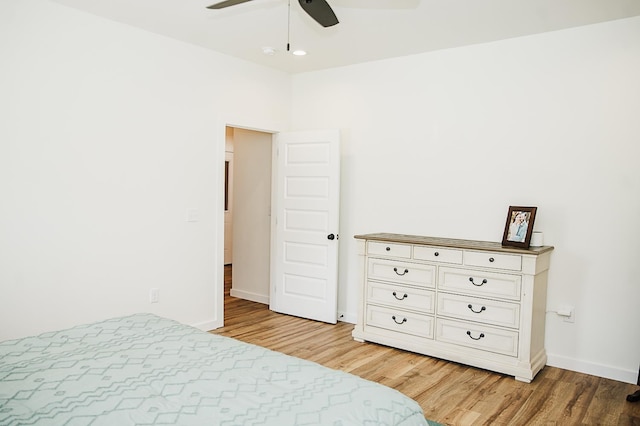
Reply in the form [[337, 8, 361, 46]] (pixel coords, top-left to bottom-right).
[[438, 267, 522, 300]]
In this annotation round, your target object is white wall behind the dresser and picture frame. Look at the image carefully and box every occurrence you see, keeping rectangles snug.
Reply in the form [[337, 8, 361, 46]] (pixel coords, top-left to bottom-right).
[[293, 18, 640, 383]]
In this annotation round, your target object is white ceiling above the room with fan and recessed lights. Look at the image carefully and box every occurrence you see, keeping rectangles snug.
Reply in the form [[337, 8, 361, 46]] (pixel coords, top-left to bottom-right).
[[53, 0, 640, 73]]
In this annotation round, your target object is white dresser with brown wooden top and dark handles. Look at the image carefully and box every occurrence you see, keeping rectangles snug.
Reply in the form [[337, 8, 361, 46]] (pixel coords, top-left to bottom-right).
[[353, 233, 553, 382]]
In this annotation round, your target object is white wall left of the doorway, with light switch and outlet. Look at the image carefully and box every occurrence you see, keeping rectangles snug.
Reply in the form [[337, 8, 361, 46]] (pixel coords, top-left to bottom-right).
[[0, 0, 291, 340]]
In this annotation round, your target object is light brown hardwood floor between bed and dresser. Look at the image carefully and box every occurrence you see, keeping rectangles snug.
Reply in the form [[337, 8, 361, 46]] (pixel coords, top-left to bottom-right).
[[212, 267, 640, 426]]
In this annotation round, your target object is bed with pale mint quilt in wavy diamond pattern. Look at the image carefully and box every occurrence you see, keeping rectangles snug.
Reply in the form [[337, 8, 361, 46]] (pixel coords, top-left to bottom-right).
[[0, 314, 436, 426]]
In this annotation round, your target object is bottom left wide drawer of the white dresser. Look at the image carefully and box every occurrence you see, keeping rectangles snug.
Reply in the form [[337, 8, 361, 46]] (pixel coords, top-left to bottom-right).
[[366, 305, 434, 339]]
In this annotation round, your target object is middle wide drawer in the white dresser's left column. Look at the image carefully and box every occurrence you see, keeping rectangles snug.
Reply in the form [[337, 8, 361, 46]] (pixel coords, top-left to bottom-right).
[[367, 281, 435, 314]]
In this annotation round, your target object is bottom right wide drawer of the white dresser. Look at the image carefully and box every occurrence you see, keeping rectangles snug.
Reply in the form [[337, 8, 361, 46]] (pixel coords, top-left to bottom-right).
[[436, 318, 518, 357]]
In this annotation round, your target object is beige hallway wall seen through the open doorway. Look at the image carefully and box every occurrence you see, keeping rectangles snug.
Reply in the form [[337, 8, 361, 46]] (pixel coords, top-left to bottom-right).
[[231, 129, 272, 304]]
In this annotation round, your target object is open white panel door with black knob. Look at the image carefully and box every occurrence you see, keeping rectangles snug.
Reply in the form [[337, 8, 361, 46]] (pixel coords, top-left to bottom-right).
[[270, 130, 340, 324]]
